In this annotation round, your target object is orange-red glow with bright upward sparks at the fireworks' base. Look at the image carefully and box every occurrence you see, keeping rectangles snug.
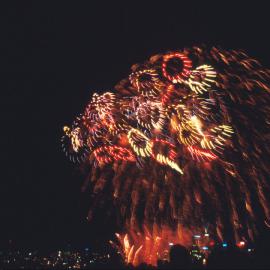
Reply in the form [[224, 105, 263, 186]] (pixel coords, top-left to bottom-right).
[[110, 225, 212, 266]]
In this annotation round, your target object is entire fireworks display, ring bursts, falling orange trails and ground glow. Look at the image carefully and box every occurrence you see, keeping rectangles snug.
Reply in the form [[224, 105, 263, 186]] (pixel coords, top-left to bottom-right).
[[61, 46, 270, 265]]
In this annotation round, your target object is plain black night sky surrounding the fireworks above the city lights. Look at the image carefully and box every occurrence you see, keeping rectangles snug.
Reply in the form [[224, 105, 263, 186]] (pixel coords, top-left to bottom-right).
[[0, 1, 270, 251]]
